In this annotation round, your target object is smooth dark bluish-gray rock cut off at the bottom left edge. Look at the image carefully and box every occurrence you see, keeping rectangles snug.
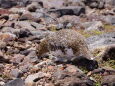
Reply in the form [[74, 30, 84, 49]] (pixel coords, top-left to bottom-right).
[[4, 78, 24, 86]]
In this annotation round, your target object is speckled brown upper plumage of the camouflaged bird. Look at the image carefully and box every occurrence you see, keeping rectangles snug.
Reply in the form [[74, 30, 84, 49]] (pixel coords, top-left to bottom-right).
[[38, 29, 92, 59]]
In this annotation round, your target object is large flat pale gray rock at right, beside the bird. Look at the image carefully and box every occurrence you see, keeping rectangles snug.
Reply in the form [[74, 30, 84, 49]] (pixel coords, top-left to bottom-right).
[[87, 32, 115, 50]]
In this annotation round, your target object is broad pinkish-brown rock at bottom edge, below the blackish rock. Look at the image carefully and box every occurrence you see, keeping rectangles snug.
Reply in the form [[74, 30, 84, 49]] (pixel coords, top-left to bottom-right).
[[53, 65, 94, 86]]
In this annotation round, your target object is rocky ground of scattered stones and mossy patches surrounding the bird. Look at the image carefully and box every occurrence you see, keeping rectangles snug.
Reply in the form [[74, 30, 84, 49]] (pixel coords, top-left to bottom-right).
[[0, 0, 115, 86]]
